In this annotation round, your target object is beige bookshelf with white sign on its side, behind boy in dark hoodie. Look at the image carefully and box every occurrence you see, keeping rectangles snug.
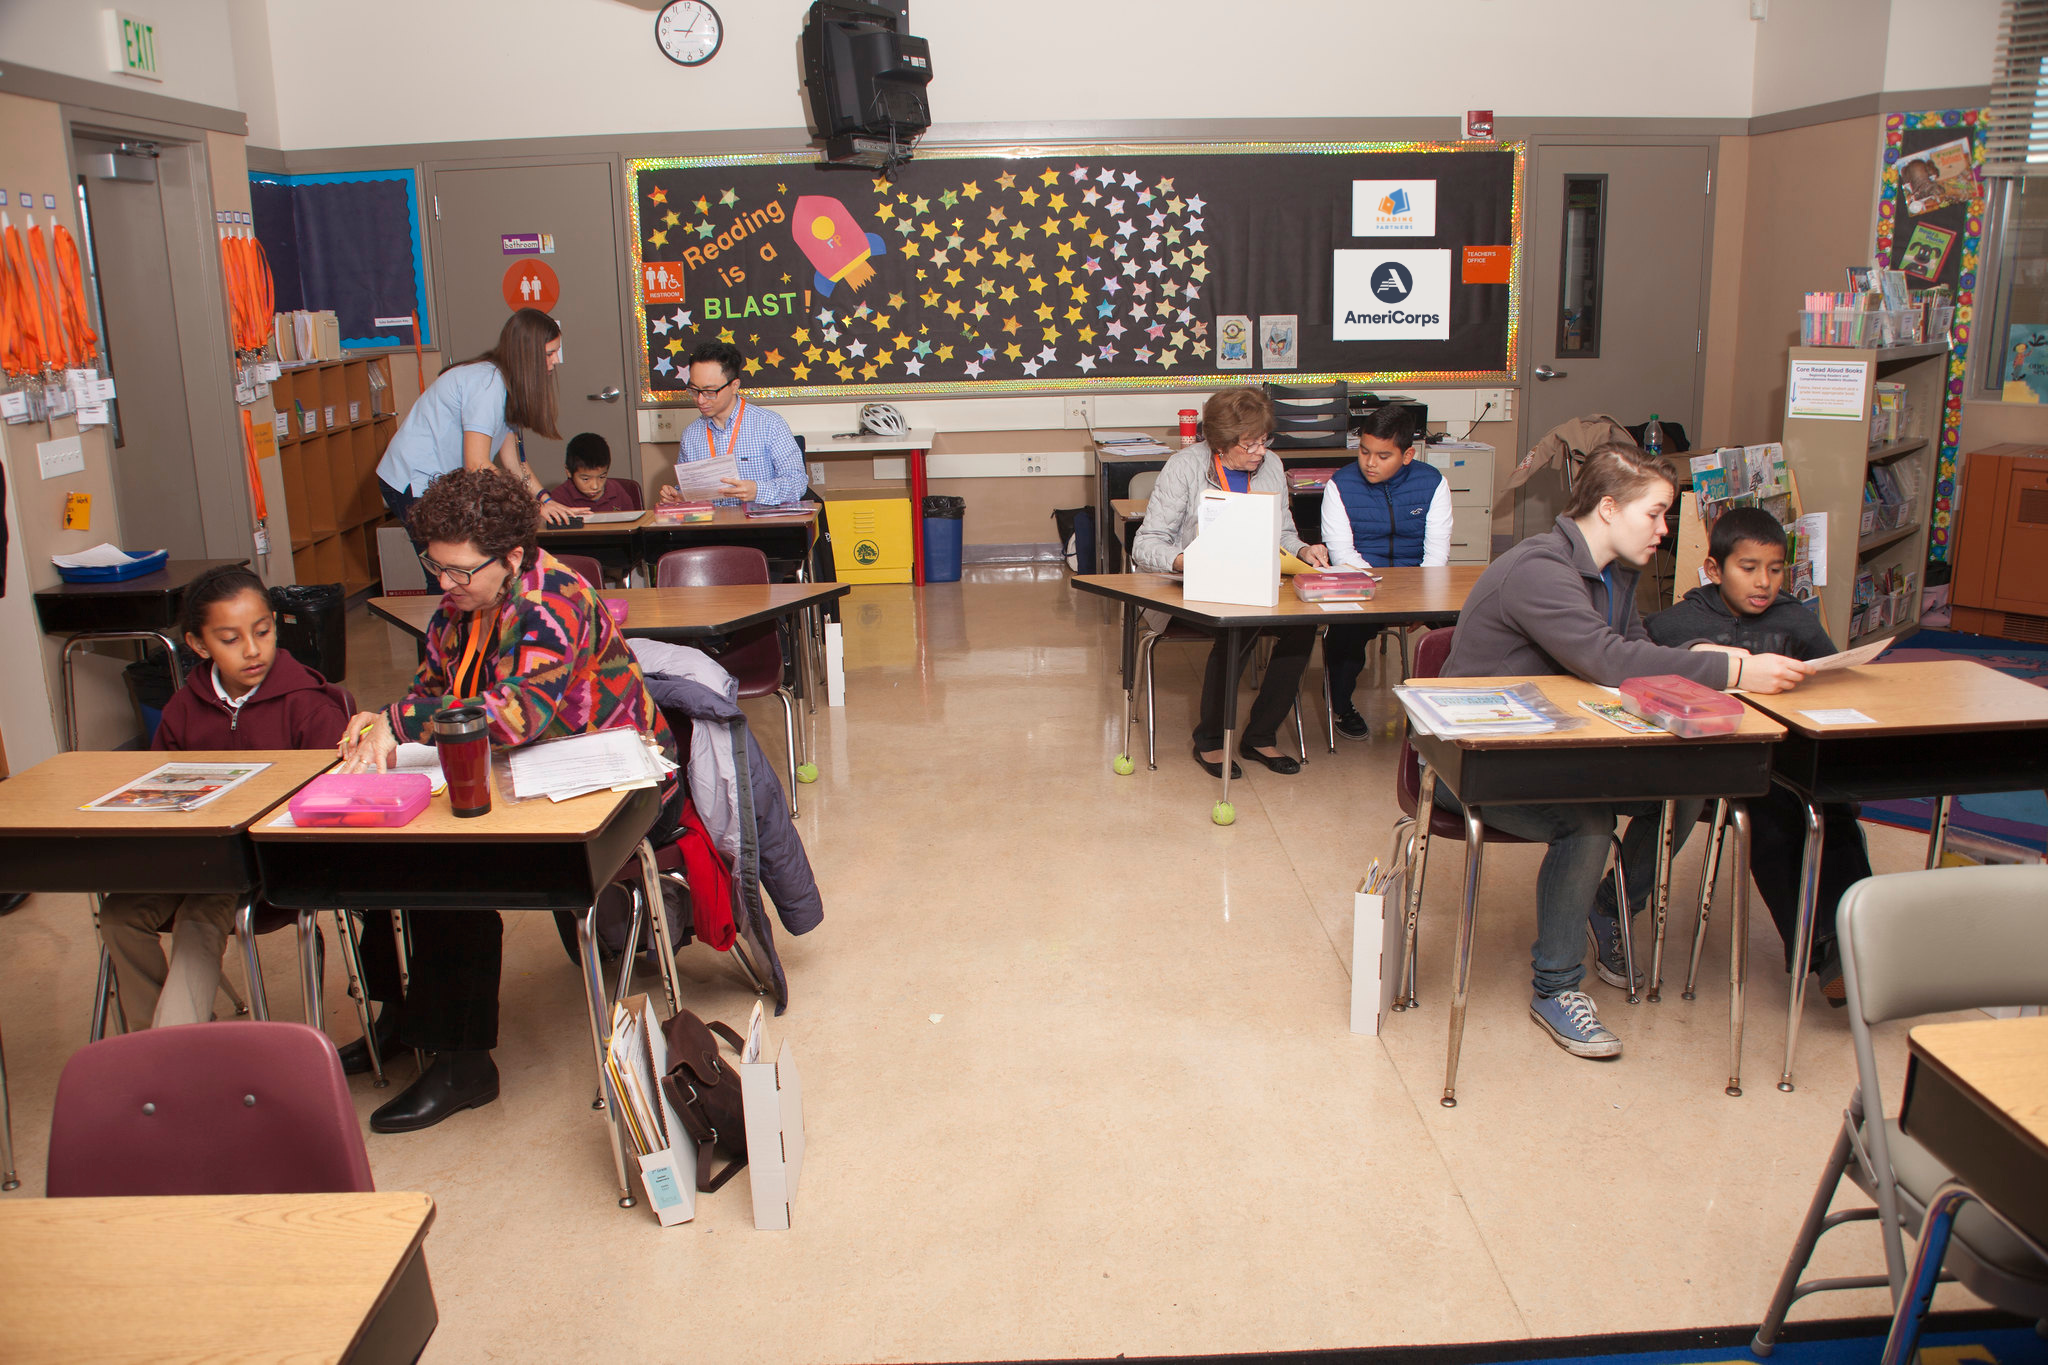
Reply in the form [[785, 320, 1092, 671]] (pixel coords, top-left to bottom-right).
[[1784, 342, 1948, 647]]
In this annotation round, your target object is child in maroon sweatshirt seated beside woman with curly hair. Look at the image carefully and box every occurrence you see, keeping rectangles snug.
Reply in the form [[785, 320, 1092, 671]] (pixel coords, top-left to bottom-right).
[[100, 565, 354, 1029]]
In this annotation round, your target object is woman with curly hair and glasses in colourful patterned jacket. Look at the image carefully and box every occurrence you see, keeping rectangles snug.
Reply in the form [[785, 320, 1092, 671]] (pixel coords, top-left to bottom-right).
[[342, 467, 680, 1134]]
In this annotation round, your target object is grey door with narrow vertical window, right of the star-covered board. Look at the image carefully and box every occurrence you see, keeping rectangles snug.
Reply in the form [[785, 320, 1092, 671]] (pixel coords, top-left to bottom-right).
[[1516, 145, 1729, 538]]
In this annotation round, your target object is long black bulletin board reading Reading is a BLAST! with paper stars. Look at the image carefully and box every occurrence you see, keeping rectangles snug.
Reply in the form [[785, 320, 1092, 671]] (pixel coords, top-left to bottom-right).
[[627, 143, 1526, 401]]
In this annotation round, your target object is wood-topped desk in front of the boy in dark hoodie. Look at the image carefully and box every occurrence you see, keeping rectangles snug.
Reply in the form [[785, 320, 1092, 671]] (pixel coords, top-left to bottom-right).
[[1743, 659, 2048, 1091]]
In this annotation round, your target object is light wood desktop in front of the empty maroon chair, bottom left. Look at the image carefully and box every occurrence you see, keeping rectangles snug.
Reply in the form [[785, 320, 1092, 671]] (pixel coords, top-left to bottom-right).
[[0, 1191, 434, 1365]]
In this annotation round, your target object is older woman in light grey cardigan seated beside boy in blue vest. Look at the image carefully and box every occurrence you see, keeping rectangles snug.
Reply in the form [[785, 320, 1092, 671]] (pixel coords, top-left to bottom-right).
[[1130, 389, 1329, 778]]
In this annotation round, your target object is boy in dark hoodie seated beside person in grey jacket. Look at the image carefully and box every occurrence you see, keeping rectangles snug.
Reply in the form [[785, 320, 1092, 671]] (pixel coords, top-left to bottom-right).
[[1646, 508, 1870, 1009]]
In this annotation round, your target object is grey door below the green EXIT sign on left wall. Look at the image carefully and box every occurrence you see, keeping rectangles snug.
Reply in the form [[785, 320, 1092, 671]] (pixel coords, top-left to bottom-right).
[[76, 137, 208, 559]]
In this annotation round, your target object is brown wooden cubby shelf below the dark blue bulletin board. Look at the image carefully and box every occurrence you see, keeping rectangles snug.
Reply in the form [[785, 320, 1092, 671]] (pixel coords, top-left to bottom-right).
[[270, 356, 397, 593]]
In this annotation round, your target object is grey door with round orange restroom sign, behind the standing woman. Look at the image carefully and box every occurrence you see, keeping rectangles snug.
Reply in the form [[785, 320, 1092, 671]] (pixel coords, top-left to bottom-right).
[[430, 162, 639, 487]]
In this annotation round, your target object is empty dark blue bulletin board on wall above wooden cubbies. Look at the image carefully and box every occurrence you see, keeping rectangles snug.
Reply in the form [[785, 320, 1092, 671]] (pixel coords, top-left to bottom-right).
[[250, 170, 434, 350]]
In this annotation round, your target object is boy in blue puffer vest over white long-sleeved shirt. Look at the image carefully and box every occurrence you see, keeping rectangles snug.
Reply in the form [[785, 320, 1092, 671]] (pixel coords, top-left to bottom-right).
[[1323, 407, 1450, 739]]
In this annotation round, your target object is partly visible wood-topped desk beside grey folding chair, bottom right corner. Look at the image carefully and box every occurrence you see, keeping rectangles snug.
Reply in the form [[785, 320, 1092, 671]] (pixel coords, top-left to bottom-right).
[[1882, 1017, 2048, 1363]]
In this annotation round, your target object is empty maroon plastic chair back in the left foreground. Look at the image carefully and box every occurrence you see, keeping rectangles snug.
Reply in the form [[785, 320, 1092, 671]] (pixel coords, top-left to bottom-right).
[[49, 1023, 377, 1199]]
